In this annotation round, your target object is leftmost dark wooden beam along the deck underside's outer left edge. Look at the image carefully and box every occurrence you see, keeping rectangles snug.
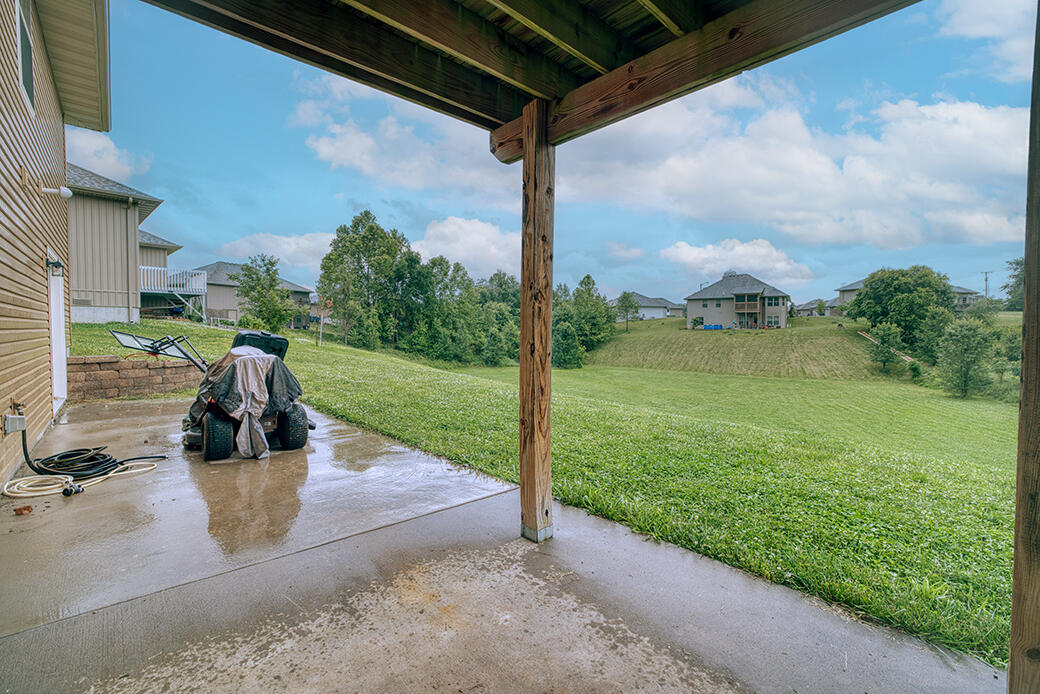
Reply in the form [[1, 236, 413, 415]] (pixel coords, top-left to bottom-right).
[[146, 0, 529, 129]]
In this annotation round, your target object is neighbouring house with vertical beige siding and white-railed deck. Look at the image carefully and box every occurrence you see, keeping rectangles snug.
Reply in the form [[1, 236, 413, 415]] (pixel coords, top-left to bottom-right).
[[67, 163, 206, 323]]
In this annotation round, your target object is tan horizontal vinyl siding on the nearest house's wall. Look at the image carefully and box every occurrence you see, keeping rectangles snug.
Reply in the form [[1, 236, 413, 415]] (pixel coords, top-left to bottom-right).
[[0, 0, 70, 480]]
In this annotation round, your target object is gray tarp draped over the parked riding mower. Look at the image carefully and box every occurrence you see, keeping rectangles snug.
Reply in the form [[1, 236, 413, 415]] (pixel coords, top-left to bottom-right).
[[185, 345, 303, 458]]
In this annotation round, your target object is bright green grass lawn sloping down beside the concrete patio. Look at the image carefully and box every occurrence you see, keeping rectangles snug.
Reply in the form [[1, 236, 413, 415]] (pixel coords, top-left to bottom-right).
[[72, 322, 1016, 664]]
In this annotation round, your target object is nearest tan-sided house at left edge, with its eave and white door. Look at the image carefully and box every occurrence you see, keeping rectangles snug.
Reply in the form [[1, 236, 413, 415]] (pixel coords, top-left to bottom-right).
[[0, 0, 110, 480]]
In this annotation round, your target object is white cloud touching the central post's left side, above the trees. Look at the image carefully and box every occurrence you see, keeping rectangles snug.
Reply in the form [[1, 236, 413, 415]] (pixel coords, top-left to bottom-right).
[[412, 216, 520, 279]]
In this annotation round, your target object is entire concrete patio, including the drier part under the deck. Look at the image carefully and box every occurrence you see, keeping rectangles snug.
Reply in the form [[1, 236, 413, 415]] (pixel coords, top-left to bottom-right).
[[0, 403, 1006, 694]]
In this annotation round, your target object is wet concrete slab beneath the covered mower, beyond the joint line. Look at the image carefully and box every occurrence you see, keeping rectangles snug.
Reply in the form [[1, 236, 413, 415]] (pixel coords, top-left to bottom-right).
[[0, 401, 511, 636]]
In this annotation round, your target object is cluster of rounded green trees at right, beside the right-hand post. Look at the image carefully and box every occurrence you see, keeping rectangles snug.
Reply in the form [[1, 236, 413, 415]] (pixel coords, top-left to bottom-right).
[[846, 259, 1022, 400]]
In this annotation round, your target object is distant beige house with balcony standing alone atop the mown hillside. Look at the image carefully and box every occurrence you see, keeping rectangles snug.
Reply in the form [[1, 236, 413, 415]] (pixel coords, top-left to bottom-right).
[[686, 272, 790, 329]]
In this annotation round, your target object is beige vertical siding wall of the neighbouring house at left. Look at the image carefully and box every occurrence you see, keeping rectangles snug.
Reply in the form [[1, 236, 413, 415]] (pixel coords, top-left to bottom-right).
[[69, 194, 141, 320]]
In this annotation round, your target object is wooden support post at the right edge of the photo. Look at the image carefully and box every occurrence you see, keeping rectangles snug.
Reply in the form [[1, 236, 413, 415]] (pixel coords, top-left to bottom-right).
[[1008, 8, 1040, 694]]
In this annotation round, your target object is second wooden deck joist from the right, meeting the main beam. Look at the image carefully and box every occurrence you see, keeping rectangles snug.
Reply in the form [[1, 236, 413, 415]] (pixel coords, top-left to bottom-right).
[[486, 0, 635, 74]]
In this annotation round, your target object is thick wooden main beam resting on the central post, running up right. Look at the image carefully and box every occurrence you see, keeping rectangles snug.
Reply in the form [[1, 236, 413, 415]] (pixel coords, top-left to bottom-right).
[[491, 0, 918, 163]]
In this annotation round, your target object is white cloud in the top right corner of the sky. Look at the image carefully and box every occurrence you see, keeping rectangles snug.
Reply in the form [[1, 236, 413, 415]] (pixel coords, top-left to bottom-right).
[[938, 0, 1037, 82]]
